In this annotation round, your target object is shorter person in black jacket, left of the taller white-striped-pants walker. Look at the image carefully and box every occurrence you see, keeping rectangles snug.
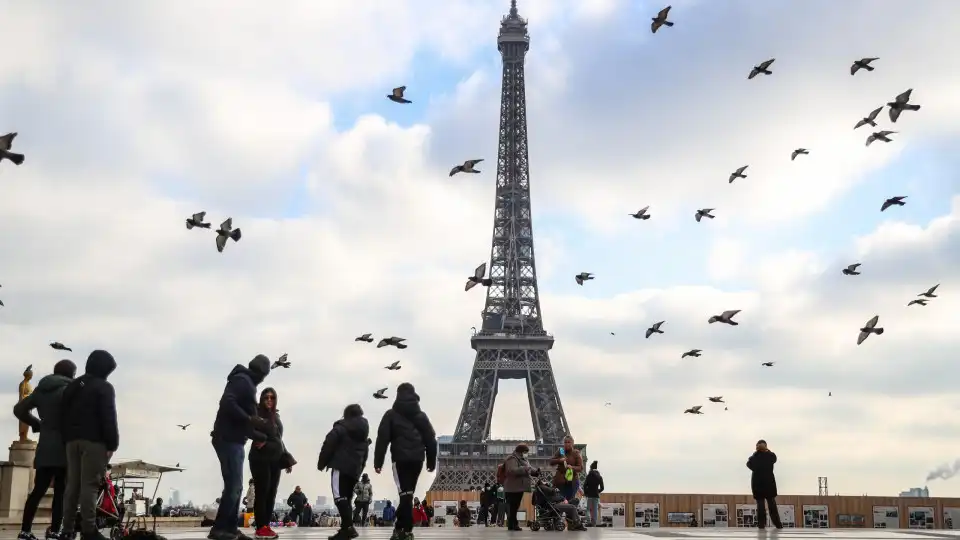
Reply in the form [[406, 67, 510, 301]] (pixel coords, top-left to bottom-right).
[[317, 403, 370, 540]]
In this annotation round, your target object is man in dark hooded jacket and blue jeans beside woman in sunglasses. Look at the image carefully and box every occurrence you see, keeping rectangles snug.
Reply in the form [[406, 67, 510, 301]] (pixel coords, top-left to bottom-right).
[[207, 354, 270, 540]]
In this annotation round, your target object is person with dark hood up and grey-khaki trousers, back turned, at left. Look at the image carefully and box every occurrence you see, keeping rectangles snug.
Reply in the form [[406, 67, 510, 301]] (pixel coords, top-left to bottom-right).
[[60, 350, 120, 540]]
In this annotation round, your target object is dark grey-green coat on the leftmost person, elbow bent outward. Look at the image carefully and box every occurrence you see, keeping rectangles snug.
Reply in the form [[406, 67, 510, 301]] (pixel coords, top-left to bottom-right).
[[13, 374, 73, 469]]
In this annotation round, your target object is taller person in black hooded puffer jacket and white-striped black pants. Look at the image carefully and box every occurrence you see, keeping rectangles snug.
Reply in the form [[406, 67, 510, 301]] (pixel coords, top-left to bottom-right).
[[373, 383, 437, 540]]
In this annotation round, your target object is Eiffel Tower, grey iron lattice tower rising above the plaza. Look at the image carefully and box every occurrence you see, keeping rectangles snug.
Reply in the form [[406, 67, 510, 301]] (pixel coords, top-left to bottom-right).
[[430, 0, 586, 491]]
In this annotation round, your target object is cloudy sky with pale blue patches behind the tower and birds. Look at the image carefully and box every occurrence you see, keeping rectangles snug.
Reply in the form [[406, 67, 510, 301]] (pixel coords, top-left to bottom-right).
[[0, 0, 960, 502]]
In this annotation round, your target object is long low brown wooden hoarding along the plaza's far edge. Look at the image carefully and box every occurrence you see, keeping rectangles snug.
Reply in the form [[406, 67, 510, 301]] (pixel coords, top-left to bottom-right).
[[426, 491, 960, 529]]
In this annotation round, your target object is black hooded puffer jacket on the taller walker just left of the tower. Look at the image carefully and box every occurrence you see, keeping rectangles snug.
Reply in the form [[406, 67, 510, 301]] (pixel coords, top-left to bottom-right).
[[373, 383, 437, 470]]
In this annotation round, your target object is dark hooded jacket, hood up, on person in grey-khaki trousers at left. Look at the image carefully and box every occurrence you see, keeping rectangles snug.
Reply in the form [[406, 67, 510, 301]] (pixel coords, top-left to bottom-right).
[[60, 350, 120, 452]]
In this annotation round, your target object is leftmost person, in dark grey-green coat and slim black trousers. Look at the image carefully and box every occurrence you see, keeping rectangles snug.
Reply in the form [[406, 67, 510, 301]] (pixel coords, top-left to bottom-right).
[[13, 360, 77, 540]]
